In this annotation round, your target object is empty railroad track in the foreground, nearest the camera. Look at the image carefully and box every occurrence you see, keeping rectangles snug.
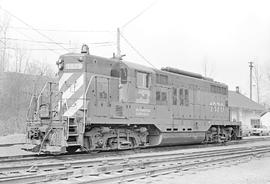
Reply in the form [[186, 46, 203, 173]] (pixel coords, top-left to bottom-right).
[[0, 145, 270, 184]]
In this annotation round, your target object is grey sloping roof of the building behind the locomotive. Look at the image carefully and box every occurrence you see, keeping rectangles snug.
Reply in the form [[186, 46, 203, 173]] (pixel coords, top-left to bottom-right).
[[229, 91, 265, 111]]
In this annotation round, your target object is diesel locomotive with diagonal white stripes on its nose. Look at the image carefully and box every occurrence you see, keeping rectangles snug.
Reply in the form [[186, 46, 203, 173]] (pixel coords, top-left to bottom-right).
[[26, 45, 241, 153]]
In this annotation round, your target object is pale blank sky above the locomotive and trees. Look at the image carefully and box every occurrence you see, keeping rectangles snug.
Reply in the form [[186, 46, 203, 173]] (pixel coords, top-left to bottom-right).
[[0, 0, 270, 100]]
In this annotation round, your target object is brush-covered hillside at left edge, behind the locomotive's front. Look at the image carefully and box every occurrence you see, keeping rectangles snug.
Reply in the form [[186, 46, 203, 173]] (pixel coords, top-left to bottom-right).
[[0, 72, 52, 135]]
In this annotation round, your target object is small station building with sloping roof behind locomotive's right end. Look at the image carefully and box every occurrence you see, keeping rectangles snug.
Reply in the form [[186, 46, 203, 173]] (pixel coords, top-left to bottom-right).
[[229, 88, 265, 128]]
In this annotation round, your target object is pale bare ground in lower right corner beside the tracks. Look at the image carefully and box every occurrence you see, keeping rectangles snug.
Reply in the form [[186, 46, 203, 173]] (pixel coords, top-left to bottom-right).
[[139, 154, 270, 184]]
